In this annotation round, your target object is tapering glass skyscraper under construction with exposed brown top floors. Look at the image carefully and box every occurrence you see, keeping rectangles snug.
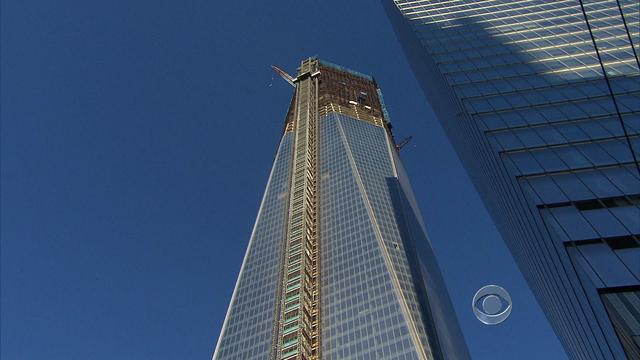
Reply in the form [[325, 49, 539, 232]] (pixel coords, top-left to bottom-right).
[[213, 58, 468, 360]]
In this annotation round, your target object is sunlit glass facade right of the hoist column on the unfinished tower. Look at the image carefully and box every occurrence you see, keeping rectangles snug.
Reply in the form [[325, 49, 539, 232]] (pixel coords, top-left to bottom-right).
[[320, 114, 431, 359]]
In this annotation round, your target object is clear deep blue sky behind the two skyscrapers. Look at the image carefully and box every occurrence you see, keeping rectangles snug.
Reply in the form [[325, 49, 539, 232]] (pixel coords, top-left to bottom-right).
[[0, 0, 561, 360]]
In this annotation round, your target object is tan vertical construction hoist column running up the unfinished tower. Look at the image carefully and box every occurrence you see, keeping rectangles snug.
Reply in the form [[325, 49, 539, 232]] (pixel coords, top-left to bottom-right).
[[274, 59, 319, 360]]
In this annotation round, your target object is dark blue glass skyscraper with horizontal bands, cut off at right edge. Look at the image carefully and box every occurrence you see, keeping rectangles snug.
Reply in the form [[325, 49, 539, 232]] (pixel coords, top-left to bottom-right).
[[383, 0, 640, 359]]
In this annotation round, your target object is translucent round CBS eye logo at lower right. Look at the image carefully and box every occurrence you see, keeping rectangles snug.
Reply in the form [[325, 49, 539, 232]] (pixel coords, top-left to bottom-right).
[[471, 285, 512, 325]]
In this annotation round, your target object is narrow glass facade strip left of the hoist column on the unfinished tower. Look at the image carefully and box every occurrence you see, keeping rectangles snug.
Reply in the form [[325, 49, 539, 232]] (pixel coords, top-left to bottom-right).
[[214, 133, 293, 360]]
